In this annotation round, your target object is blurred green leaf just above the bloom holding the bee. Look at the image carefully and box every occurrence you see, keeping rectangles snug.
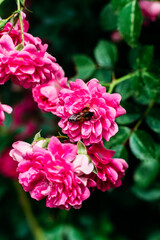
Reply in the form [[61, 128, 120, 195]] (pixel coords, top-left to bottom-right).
[[73, 55, 96, 79]]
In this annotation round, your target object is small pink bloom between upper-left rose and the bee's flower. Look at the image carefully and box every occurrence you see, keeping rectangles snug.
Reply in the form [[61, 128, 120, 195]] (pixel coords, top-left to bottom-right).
[[32, 68, 67, 114]]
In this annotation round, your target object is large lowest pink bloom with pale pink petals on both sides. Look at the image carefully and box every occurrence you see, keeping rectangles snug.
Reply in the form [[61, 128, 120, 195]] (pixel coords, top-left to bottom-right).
[[10, 137, 93, 210]]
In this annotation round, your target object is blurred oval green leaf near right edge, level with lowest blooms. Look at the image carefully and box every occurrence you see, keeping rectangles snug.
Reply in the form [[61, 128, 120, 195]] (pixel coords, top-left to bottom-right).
[[134, 160, 159, 188]]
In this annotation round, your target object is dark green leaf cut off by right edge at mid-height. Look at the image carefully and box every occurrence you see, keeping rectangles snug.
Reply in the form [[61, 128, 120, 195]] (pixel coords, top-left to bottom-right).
[[145, 107, 160, 133]]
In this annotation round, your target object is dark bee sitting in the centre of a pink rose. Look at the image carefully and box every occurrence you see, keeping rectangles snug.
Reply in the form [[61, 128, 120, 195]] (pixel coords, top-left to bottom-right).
[[68, 107, 93, 123]]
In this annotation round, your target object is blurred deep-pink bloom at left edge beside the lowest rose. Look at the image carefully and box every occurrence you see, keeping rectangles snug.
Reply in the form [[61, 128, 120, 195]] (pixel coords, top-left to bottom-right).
[[0, 148, 18, 179]]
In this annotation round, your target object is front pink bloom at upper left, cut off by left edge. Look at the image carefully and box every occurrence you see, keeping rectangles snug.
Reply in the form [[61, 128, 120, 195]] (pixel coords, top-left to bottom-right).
[[0, 35, 60, 88]]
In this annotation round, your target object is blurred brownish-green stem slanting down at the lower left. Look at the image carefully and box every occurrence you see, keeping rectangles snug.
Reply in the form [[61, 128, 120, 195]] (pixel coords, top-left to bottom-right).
[[14, 181, 46, 240]]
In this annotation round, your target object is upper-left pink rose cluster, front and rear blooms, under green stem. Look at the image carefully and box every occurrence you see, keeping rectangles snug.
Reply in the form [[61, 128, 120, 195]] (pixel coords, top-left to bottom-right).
[[0, 12, 65, 88]]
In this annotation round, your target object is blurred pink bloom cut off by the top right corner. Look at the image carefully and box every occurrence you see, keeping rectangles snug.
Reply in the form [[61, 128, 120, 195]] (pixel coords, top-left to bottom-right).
[[139, 0, 160, 21]]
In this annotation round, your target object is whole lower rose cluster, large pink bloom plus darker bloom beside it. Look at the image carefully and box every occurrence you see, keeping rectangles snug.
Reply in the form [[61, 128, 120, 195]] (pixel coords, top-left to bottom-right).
[[10, 137, 127, 210]]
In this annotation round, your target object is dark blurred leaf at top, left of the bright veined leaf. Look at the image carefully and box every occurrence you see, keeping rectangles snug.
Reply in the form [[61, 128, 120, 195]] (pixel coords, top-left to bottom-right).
[[100, 4, 117, 31]]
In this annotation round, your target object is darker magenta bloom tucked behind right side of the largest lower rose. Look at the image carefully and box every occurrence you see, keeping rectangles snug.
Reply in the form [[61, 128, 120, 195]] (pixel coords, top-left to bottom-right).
[[88, 142, 128, 192]]
